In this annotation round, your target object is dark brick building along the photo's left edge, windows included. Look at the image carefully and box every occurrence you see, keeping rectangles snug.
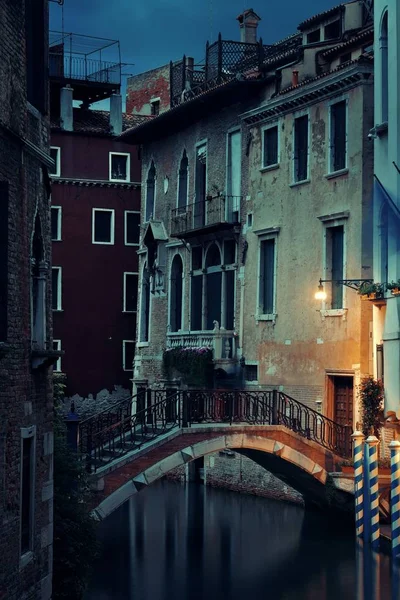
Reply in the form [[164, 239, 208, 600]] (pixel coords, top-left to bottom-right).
[[0, 0, 57, 600]]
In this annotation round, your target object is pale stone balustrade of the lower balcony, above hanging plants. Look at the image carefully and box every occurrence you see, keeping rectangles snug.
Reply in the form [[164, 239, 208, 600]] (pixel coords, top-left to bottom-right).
[[167, 329, 237, 360]]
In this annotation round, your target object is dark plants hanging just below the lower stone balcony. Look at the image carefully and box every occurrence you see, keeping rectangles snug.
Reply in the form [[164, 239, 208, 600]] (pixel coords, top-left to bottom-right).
[[163, 346, 213, 386]]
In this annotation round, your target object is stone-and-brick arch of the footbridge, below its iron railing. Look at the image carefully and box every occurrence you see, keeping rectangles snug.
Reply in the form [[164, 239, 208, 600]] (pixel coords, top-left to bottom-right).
[[93, 426, 333, 520]]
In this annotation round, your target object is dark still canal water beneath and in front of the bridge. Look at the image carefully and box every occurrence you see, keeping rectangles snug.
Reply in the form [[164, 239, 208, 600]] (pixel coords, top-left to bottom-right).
[[85, 481, 400, 600]]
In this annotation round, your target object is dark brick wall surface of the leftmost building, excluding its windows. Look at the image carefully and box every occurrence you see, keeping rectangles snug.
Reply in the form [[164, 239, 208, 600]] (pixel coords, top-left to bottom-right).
[[0, 0, 53, 600]]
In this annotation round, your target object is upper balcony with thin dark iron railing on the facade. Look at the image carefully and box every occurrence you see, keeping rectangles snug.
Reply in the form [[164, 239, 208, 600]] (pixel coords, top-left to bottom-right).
[[171, 196, 241, 238]]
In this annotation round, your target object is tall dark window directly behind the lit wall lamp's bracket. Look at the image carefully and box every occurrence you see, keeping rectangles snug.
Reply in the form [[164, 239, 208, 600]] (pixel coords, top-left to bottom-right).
[[325, 225, 344, 309]]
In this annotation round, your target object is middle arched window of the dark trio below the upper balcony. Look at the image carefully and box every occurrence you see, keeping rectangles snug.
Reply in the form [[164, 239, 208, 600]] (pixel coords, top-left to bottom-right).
[[205, 244, 222, 330]]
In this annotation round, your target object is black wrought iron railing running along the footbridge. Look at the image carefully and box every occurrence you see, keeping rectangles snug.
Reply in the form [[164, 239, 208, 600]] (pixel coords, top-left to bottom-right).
[[78, 389, 352, 471]]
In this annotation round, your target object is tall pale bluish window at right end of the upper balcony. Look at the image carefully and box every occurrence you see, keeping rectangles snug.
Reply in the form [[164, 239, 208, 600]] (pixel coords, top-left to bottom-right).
[[226, 131, 242, 223]]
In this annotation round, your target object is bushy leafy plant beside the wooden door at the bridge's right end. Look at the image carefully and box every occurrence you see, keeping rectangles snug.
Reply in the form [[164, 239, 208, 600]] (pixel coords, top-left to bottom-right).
[[359, 377, 383, 439]]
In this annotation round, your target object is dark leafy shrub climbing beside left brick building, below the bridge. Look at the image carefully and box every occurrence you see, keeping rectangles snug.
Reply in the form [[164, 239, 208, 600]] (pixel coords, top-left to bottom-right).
[[53, 374, 98, 600]]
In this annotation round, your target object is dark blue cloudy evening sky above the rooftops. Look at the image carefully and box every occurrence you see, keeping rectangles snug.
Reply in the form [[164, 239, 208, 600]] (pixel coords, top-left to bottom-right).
[[50, 0, 339, 104]]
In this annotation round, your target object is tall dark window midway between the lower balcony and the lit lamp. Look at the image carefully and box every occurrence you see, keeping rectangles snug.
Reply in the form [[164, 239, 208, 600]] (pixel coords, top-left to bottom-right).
[[258, 237, 276, 316]]
